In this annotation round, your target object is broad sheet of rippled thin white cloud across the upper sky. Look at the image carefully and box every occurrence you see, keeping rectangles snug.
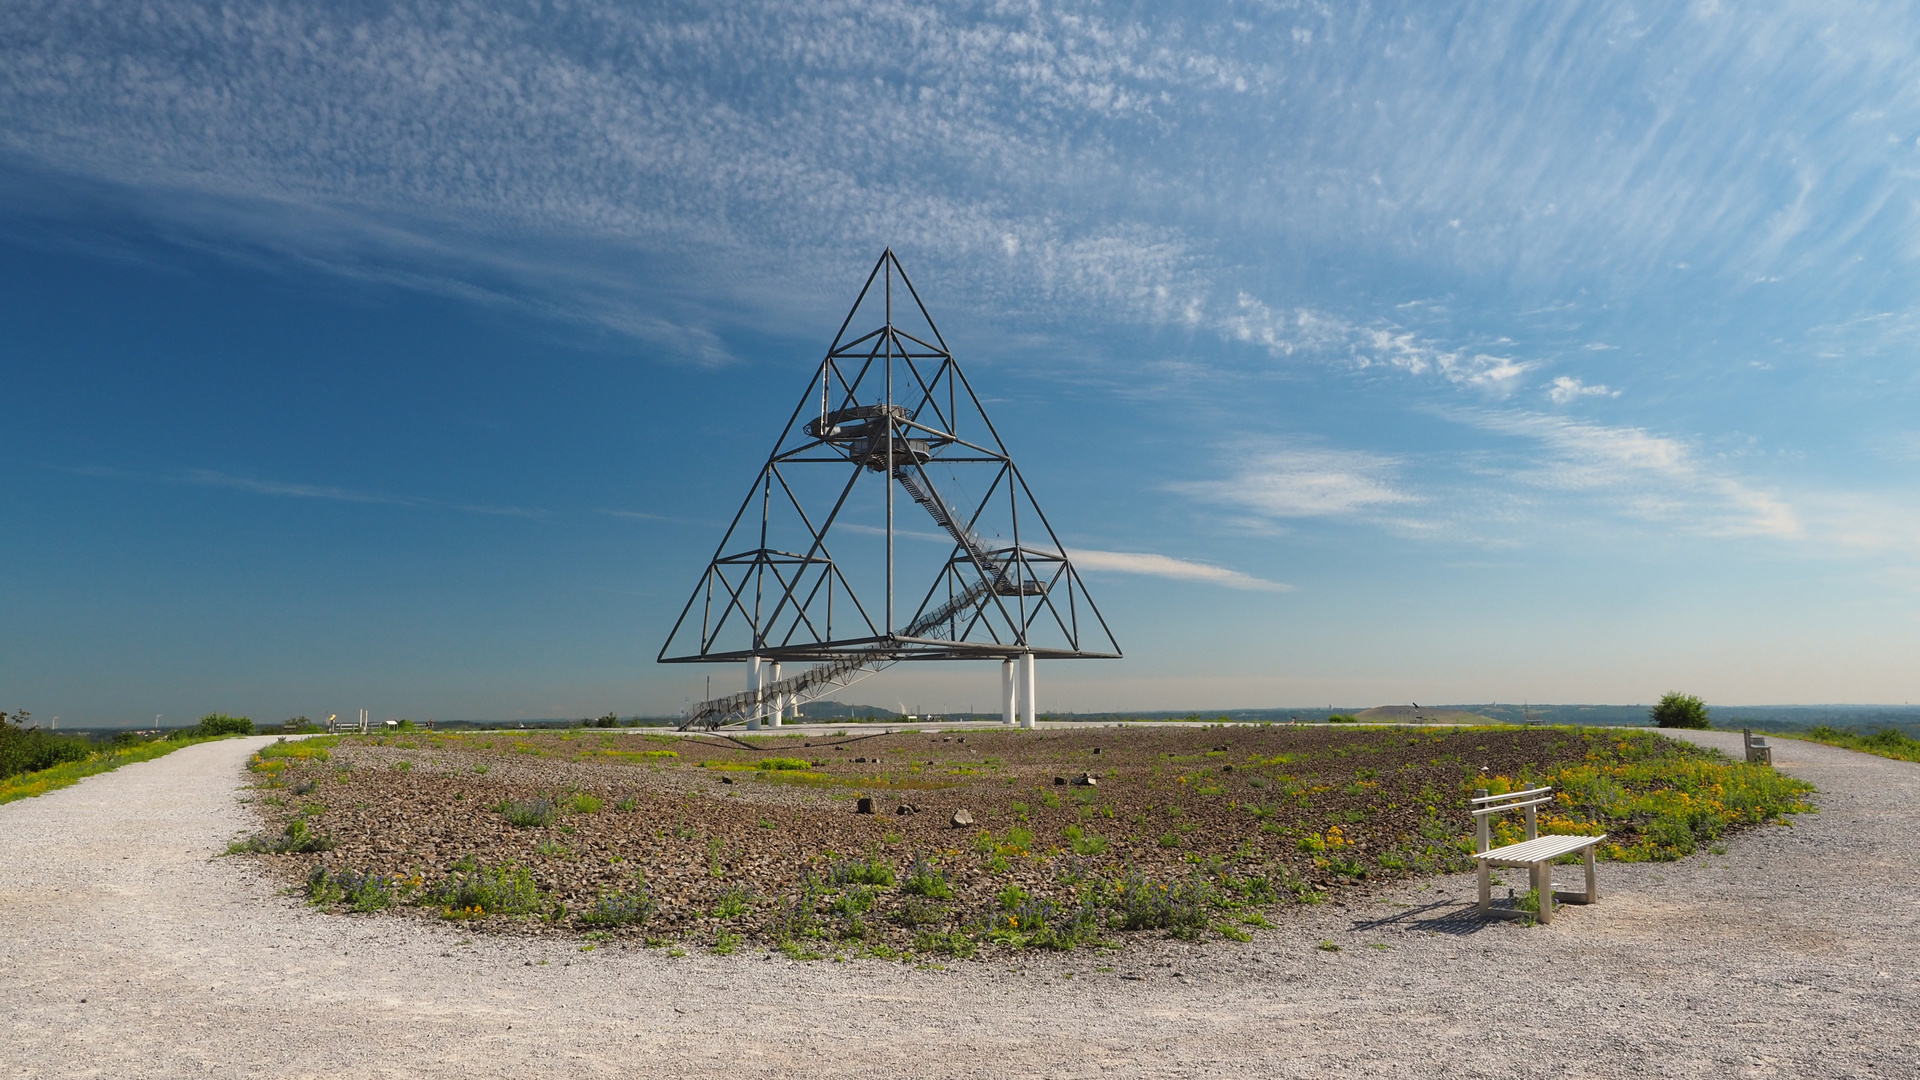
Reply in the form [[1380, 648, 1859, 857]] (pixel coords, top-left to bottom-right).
[[0, 0, 1920, 363]]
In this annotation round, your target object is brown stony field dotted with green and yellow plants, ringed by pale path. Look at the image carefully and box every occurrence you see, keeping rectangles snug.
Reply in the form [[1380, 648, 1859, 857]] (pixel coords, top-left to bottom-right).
[[238, 724, 1795, 957]]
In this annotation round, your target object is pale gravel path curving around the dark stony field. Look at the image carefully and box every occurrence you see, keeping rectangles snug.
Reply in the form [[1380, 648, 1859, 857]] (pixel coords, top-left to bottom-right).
[[0, 734, 1920, 1078]]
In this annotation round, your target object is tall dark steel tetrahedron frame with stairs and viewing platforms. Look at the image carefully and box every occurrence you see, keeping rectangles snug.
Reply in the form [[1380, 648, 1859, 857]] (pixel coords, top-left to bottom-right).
[[659, 250, 1119, 726]]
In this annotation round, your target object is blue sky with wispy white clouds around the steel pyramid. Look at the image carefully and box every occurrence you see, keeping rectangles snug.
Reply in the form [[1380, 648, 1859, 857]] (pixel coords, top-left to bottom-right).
[[0, 2, 1920, 723]]
